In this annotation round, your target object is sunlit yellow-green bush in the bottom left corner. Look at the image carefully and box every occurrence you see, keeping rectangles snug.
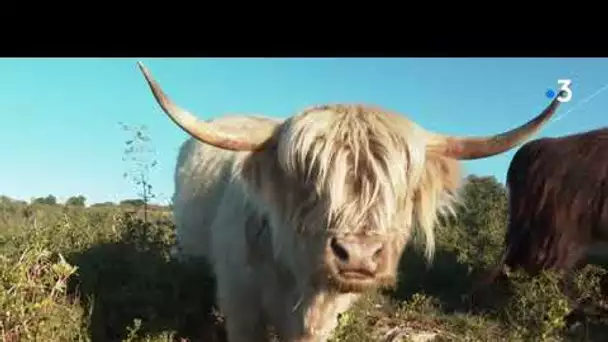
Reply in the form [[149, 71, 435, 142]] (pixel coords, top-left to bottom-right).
[[0, 245, 86, 341]]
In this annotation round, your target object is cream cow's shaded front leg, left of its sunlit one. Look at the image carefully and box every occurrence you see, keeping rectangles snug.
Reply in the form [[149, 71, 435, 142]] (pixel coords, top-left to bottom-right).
[[217, 278, 268, 342]]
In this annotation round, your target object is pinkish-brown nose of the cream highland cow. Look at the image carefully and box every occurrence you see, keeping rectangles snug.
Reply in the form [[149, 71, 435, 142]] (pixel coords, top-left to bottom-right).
[[329, 236, 384, 276]]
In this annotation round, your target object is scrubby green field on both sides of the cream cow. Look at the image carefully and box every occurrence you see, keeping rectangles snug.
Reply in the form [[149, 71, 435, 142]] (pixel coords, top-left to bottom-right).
[[0, 176, 608, 342]]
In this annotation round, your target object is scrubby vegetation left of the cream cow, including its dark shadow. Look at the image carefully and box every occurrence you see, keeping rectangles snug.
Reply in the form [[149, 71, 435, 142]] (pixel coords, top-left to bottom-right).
[[0, 200, 221, 342]]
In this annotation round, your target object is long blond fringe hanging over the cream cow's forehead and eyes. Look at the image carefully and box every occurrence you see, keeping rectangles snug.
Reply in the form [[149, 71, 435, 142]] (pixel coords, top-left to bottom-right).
[[270, 104, 431, 236]]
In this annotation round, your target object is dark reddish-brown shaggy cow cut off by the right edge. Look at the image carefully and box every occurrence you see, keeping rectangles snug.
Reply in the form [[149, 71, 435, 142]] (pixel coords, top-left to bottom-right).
[[496, 128, 608, 274]]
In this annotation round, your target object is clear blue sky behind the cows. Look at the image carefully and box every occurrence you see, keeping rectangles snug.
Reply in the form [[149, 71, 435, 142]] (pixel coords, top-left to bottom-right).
[[0, 58, 608, 204]]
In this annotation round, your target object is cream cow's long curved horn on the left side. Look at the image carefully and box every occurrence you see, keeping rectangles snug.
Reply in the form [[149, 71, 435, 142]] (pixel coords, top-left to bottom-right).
[[137, 62, 276, 151]]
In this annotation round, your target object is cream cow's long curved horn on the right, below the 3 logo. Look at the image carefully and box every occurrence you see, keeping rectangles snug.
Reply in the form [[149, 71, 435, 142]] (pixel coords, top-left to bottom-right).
[[428, 91, 565, 160]]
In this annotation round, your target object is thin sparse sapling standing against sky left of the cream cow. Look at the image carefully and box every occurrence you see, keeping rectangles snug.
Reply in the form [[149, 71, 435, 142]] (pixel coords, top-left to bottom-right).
[[120, 123, 157, 222]]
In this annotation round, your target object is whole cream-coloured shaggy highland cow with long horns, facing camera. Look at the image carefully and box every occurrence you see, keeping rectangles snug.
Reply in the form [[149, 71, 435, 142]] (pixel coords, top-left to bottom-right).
[[139, 63, 559, 342]]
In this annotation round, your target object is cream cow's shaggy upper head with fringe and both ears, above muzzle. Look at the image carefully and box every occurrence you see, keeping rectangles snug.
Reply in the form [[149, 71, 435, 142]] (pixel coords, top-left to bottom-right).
[[236, 105, 460, 259]]
